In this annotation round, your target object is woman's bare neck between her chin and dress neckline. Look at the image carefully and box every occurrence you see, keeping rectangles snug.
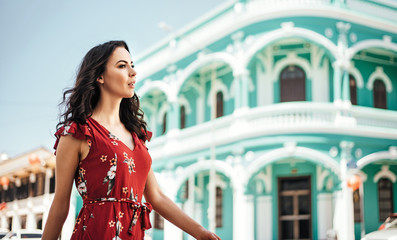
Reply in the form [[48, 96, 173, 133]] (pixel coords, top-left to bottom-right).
[[91, 98, 122, 126]]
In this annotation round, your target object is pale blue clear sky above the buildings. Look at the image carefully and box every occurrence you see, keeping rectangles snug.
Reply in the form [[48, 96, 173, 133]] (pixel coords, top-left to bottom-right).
[[0, 0, 227, 158]]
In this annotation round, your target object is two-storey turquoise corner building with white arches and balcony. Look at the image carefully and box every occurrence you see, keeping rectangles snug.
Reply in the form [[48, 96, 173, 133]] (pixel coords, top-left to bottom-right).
[[136, 0, 397, 240]]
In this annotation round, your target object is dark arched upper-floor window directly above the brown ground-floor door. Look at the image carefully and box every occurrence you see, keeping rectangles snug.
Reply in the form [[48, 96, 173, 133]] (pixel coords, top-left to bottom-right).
[[280, 65, 306, 102]]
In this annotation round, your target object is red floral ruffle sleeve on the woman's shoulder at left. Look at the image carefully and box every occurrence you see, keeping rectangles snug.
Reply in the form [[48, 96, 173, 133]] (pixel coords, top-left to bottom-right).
[[54, 122, 92, 154]]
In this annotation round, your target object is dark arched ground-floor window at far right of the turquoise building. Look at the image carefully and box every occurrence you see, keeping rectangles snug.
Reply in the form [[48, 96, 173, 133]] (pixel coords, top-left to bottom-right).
[[378, 178, 393, 222]]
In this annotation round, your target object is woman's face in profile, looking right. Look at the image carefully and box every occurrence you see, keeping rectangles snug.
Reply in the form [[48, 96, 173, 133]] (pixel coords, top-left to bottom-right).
[[98, 47, 136, 98]]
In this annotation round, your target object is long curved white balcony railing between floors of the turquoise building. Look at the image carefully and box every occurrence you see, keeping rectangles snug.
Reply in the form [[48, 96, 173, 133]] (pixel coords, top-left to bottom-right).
[[149, 102, 397, 159]]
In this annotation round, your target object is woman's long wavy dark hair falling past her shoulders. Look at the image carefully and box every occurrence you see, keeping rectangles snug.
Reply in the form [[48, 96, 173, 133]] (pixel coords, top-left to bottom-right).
[[57, 41, 147, 139]]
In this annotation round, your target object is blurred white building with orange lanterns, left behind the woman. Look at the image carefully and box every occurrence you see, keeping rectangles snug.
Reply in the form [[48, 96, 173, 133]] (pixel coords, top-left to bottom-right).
[[0, 148, 77, 239]]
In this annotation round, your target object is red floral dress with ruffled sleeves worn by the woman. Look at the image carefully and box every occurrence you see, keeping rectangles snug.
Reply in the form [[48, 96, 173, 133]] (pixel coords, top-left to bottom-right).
[[54, 118, 152, 240]]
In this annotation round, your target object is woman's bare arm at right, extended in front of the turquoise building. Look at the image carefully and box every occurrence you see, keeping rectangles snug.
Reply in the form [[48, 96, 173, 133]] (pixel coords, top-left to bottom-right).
[[144, 169, 221, 240]]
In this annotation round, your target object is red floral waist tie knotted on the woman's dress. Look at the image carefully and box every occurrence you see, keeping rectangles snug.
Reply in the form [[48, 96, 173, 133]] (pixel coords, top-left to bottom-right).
[[83, 198, 152, 236]]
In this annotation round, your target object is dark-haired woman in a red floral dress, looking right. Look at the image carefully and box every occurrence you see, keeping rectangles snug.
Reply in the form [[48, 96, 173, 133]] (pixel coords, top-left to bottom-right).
[[43, 41, 220, 240]]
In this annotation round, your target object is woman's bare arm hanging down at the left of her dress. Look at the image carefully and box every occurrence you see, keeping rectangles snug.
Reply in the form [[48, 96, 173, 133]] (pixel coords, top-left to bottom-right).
[[42, 135, 83, 240]]
